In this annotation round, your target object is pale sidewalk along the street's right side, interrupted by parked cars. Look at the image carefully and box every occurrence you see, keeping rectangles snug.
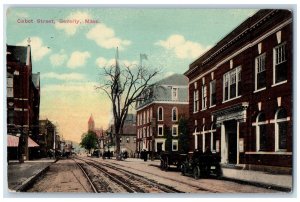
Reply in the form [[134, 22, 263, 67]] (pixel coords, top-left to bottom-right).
[[128, 158, 293, 192]]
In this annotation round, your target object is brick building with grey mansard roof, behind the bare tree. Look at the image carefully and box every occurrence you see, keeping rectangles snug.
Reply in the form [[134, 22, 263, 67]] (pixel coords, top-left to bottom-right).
[[136, 74, 188, 154]]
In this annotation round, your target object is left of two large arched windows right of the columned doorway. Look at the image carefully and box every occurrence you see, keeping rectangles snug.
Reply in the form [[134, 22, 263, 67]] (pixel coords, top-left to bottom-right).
[[255, 112, 268, 151]]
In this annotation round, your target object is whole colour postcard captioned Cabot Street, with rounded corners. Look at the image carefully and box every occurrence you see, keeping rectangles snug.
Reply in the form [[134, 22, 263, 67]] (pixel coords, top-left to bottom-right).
[[4, 6, 295, 197]]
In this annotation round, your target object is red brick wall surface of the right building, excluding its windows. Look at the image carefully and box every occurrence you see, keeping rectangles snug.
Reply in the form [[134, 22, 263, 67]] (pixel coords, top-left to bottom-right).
[[188, 9, 293, 167]]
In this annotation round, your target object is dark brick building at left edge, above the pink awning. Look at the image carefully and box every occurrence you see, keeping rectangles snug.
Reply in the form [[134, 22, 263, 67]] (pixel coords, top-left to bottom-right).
[[6, 45, 40, 159]]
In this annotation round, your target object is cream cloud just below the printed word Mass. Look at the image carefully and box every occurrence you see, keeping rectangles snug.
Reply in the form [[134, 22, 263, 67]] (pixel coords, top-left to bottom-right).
[[86, 24, 131, 50]]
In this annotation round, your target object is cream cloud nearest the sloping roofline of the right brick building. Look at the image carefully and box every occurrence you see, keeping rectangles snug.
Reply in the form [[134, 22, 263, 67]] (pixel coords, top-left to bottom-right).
[[155, 34, 209, 59]]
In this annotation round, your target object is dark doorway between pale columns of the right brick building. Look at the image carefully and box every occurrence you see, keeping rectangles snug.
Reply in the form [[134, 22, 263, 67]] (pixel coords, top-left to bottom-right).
[[225, 120, 237, 164]]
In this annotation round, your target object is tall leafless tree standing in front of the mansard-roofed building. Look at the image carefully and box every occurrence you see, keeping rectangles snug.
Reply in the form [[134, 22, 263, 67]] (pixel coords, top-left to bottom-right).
[[96, 50, 159, 159]]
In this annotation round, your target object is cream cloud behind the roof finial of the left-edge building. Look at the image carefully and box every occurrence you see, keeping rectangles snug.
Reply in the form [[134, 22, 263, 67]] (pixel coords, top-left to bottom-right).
[[17, 36, 51, 61]]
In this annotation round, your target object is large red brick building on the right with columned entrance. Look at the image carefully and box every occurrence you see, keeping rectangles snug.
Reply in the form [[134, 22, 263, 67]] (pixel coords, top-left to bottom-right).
[[185, 10, 293, 172]]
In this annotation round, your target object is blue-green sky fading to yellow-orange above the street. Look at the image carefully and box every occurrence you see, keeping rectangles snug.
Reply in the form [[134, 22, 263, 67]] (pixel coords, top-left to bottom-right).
[[5, 6, 257, 142]]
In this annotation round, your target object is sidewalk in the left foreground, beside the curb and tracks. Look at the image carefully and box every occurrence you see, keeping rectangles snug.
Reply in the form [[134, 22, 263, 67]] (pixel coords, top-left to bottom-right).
[[7, 158, 55, 192]]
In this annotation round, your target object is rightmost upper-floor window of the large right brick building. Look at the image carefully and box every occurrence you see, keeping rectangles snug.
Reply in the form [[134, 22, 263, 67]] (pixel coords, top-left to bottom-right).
[[273, 43, 287, 84]]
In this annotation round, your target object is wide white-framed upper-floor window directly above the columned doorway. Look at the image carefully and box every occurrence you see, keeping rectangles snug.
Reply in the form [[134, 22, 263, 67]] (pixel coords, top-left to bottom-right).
[[223, 67, 241, 101]]
